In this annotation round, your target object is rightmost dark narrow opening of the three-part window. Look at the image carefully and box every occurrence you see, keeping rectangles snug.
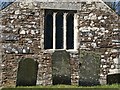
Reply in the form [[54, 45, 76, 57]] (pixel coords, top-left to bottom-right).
[[66, 14, 74, 49]]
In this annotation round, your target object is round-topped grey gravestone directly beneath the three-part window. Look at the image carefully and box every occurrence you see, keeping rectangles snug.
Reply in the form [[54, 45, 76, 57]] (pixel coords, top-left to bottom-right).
[[52, 51, 71, 85]]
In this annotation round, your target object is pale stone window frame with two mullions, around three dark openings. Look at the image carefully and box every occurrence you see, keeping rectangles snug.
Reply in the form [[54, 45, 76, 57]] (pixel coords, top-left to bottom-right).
[[43, 9, 78, 52]]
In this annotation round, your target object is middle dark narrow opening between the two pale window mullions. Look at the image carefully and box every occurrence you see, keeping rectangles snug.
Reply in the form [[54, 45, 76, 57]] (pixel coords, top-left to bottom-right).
[[56, 13, 63, 49]]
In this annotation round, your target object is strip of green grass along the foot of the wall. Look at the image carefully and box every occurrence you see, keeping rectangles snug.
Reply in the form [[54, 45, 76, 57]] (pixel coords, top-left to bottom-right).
[[2, 84, 120, 90]]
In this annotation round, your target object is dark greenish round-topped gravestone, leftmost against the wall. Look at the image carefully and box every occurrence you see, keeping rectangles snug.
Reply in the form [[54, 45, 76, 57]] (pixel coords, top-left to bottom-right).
[[16, 58, 38, 86]]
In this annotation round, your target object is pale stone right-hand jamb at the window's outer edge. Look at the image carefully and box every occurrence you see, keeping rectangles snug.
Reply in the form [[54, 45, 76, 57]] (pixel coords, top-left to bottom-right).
[[74, 13, 78, 50]]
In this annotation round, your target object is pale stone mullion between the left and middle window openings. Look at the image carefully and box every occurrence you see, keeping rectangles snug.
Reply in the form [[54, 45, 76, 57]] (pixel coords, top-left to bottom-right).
[[53, 13, 57, 50]]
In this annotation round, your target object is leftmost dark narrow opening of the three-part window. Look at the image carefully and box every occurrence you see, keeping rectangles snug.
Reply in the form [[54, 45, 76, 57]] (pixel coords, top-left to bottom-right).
[[44, 14, 53, 49]]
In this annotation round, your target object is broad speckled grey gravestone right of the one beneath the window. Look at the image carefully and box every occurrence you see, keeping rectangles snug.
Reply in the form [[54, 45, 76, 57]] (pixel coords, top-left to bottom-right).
[[79, 51, 100, 86]]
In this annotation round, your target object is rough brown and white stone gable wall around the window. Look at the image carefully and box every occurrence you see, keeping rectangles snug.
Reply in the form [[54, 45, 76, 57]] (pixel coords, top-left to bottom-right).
[[0, 1, 120, 86]]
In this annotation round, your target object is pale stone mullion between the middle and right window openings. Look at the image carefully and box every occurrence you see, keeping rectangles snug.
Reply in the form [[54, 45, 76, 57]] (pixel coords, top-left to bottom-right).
[[63, 13, 67, 49]]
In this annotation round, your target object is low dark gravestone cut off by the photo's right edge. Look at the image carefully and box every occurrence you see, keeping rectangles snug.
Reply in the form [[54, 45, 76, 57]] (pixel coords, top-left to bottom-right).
[[107, 73, 120, 84]]
